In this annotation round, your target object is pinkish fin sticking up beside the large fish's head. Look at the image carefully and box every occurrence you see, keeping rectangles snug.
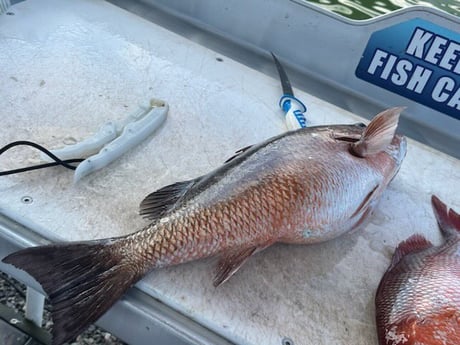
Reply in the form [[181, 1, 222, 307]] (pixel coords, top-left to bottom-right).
[[351, 107, 405, 158]]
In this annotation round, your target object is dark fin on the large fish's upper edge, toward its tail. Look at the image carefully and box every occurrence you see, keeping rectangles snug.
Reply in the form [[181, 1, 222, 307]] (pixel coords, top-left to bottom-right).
[[139, 178, 199, 220]]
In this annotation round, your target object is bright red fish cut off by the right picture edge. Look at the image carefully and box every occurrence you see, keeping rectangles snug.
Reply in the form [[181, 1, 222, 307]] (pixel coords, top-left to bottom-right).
[[375, 196, 460, 345]]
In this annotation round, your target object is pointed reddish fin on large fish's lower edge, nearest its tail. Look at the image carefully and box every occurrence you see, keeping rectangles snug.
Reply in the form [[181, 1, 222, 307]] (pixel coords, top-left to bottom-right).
[[213, 246, 267, 287]]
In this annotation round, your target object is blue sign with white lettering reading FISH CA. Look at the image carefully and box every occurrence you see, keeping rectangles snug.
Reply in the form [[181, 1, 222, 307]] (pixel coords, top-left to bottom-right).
[[355, 18, 460, 120]]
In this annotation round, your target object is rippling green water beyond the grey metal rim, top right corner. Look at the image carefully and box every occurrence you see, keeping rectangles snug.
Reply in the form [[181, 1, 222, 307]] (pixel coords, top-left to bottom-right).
[[303, 0, 460, 20]]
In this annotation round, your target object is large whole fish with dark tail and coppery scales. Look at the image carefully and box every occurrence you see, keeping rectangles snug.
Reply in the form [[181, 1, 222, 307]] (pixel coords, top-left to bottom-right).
[[3, 108, 406, 344]]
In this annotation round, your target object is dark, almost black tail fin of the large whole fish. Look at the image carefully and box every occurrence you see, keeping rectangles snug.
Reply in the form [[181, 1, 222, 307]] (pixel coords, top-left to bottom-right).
[[2, 240, 139, 345]]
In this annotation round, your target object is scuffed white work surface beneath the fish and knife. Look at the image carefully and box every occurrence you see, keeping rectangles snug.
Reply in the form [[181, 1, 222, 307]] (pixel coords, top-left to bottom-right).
[[0, 0, 460, 345]]
